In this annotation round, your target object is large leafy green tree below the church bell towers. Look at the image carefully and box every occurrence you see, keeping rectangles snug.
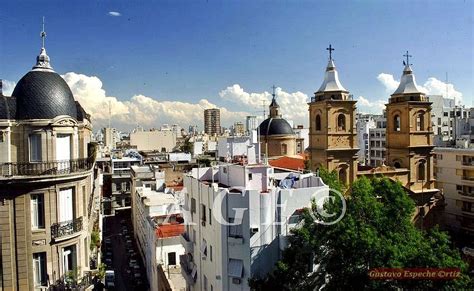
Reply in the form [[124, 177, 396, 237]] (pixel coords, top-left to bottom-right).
[[250, 175, 474, 290]]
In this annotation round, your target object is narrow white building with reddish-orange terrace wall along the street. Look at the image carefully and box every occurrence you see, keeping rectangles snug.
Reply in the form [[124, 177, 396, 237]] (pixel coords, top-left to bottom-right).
[[132, 167, 186, 290]]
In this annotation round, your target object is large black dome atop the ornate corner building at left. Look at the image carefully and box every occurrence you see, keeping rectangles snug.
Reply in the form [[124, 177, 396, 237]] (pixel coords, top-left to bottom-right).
[[12, 70, 77, 120]]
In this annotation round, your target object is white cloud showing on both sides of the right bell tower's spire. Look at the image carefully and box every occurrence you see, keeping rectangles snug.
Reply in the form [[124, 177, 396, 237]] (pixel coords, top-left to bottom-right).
[[377, 73, 462, 102]]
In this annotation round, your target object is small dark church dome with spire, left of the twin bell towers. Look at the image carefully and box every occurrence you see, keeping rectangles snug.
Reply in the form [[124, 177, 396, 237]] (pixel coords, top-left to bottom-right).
[[258, 88, 296, 157]]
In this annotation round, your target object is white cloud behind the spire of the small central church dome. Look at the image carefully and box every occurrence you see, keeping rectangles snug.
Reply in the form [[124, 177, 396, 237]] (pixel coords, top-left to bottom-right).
[[219, 84, 308, 125]]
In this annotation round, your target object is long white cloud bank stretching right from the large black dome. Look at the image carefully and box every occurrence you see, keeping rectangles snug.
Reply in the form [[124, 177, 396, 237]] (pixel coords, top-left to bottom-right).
[[62, 72, 249, 130]]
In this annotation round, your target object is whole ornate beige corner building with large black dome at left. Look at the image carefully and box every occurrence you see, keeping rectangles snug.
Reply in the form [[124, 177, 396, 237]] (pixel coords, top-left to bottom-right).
[[0, 34, 98, 290]]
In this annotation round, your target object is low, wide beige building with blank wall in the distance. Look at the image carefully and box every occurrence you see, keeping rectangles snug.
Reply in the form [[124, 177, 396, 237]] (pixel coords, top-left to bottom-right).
[[130, 130, 177, 152]]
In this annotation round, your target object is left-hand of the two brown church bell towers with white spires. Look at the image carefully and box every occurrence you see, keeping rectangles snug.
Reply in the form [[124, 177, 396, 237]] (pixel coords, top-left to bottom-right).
[[309, 46, 359, 185]]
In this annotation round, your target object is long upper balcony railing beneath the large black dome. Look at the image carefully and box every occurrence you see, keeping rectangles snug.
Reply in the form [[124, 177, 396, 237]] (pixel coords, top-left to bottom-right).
[[0, 158, 94, 177]]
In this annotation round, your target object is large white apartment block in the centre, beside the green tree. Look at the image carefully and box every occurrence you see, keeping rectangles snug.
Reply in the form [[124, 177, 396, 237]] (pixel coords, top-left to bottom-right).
[[180, 164, 329, 290]]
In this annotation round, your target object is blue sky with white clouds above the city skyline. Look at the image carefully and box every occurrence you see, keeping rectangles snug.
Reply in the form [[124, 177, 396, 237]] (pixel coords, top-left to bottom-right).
[[0, 0, 474, 130]]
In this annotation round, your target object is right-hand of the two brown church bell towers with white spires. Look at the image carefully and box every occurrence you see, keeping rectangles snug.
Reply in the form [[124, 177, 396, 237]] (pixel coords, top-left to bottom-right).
[[386, 52, 438, 198]]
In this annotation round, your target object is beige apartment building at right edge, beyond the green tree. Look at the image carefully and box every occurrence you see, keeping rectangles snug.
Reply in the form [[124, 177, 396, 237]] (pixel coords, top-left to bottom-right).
[[434, 148, 474, 235]]
